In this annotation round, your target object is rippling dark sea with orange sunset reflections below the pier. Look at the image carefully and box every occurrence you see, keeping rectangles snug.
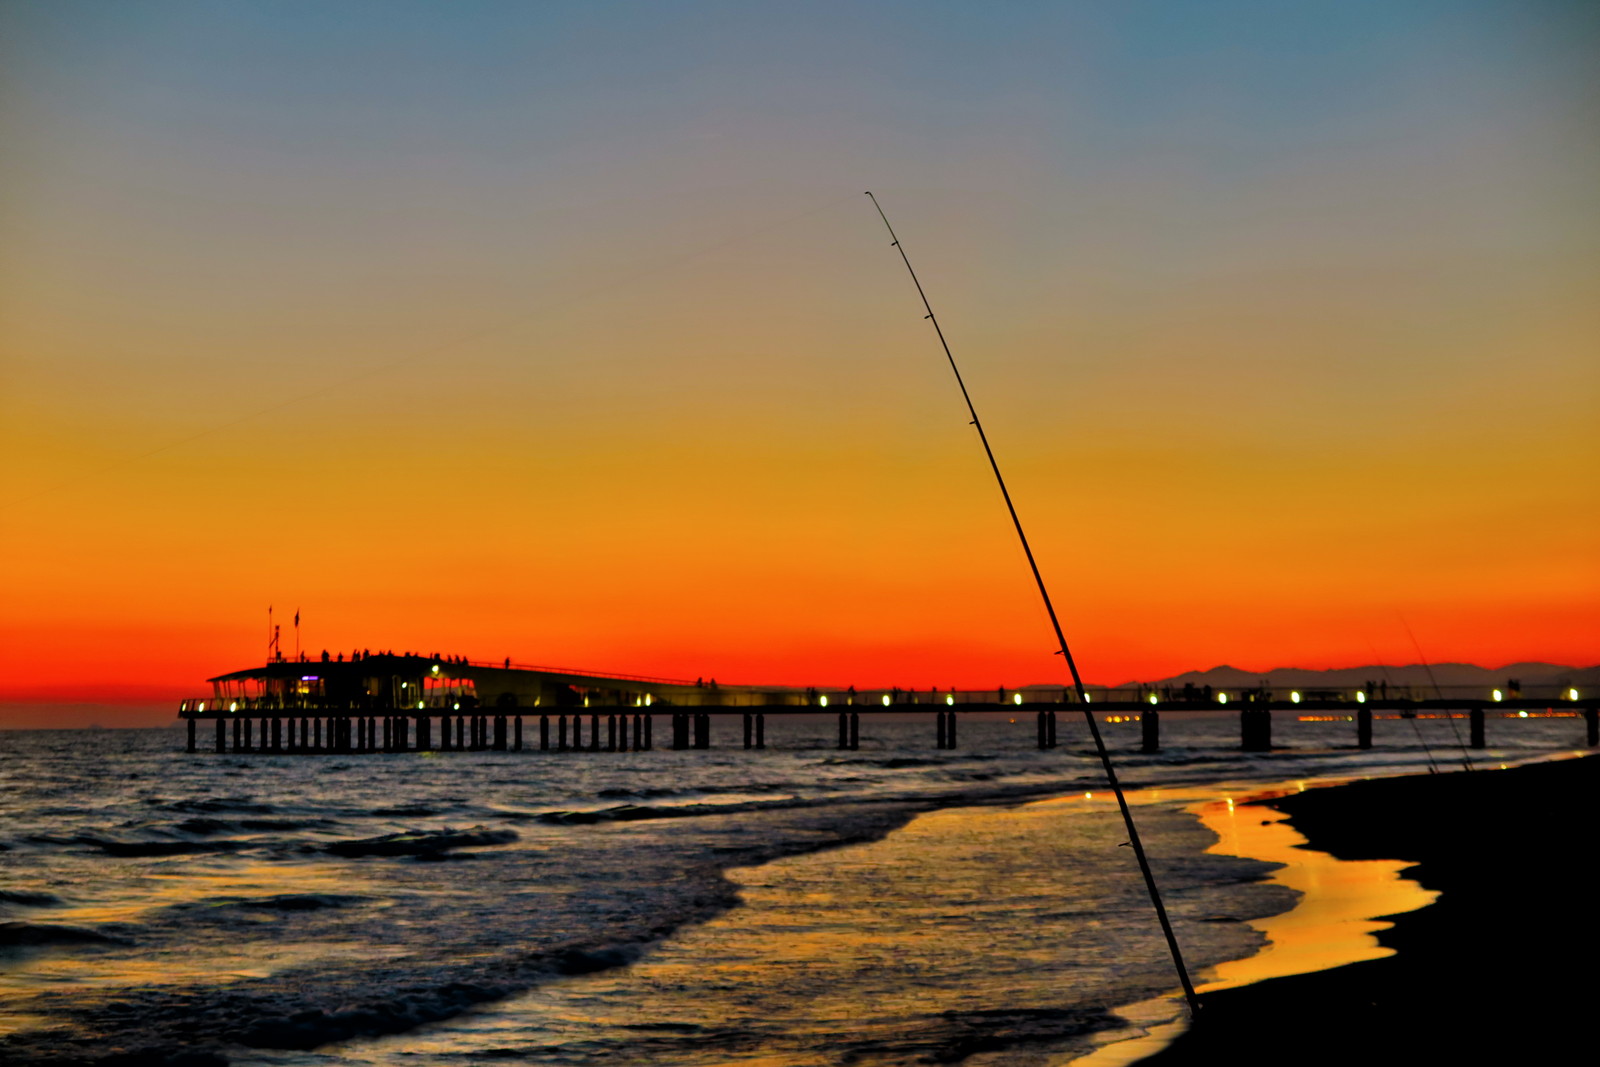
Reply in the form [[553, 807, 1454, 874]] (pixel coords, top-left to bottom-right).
[[0, 713, 1584, 1067]]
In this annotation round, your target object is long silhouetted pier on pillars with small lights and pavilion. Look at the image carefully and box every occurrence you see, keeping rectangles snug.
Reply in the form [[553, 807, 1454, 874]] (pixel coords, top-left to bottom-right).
[[178, 654, 1600, 753]]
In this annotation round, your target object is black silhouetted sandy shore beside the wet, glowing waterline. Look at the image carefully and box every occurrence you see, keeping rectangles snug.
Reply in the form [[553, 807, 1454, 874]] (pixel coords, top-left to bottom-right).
[[1139, 757, 1600, 1067]]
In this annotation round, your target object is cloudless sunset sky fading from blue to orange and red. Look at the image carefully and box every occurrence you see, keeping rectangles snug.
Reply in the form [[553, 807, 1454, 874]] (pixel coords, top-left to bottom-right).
[[0, 0, 1600, 721]]
